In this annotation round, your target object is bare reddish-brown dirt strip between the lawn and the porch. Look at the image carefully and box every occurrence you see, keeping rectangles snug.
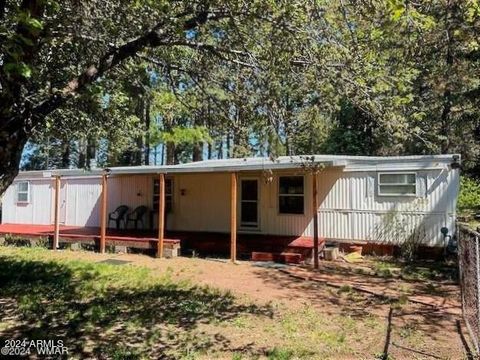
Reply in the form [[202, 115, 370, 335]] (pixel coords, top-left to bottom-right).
[[18, 251, 472, 359]]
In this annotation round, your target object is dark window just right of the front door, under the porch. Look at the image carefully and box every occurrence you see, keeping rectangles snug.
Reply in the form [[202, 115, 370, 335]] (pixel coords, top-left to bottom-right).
[[278, 176, 304, 214]]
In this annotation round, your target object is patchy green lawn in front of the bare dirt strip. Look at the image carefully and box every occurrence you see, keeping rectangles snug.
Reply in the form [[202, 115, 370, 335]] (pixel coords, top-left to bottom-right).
[[0, 247, 383, 359]]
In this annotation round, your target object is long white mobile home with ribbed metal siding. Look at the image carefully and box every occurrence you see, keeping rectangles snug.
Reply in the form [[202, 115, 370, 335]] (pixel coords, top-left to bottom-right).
[[0, 155, 460, 258]]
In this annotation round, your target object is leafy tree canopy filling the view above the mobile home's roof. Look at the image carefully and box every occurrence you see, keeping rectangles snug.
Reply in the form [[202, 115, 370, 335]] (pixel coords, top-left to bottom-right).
[[0, 0, 480, 191]]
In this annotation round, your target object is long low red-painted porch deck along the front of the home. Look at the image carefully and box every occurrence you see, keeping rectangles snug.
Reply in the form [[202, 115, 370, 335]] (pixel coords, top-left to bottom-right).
[[0, 224, 324, 258]]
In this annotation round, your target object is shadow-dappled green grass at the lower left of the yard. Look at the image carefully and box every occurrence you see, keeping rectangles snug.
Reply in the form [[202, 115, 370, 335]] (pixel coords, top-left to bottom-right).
[[0, 257, 272, 359]]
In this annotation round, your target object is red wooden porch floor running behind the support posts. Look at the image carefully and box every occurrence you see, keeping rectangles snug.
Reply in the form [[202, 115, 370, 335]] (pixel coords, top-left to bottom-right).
[[0, 224, 324, 263]]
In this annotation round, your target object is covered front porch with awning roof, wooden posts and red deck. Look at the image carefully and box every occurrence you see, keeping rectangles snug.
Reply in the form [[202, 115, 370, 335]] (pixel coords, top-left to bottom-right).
[[0, 158, 342, 266]]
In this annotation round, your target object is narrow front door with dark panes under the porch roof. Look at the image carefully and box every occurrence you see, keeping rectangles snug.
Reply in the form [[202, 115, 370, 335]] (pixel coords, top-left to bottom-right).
[[240, 179, 258, 229]]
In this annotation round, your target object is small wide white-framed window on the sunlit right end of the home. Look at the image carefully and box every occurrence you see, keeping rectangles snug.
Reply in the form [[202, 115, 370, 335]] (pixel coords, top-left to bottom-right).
[[378, 173, 417, 196]]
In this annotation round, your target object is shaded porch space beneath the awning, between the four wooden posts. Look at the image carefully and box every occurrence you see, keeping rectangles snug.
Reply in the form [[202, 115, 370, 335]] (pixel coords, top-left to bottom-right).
[[48, 169, 321, 266]]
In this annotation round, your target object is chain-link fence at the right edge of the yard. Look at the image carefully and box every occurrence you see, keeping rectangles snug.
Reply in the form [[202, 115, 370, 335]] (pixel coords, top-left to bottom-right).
[[458, 225, 480, 354]]
